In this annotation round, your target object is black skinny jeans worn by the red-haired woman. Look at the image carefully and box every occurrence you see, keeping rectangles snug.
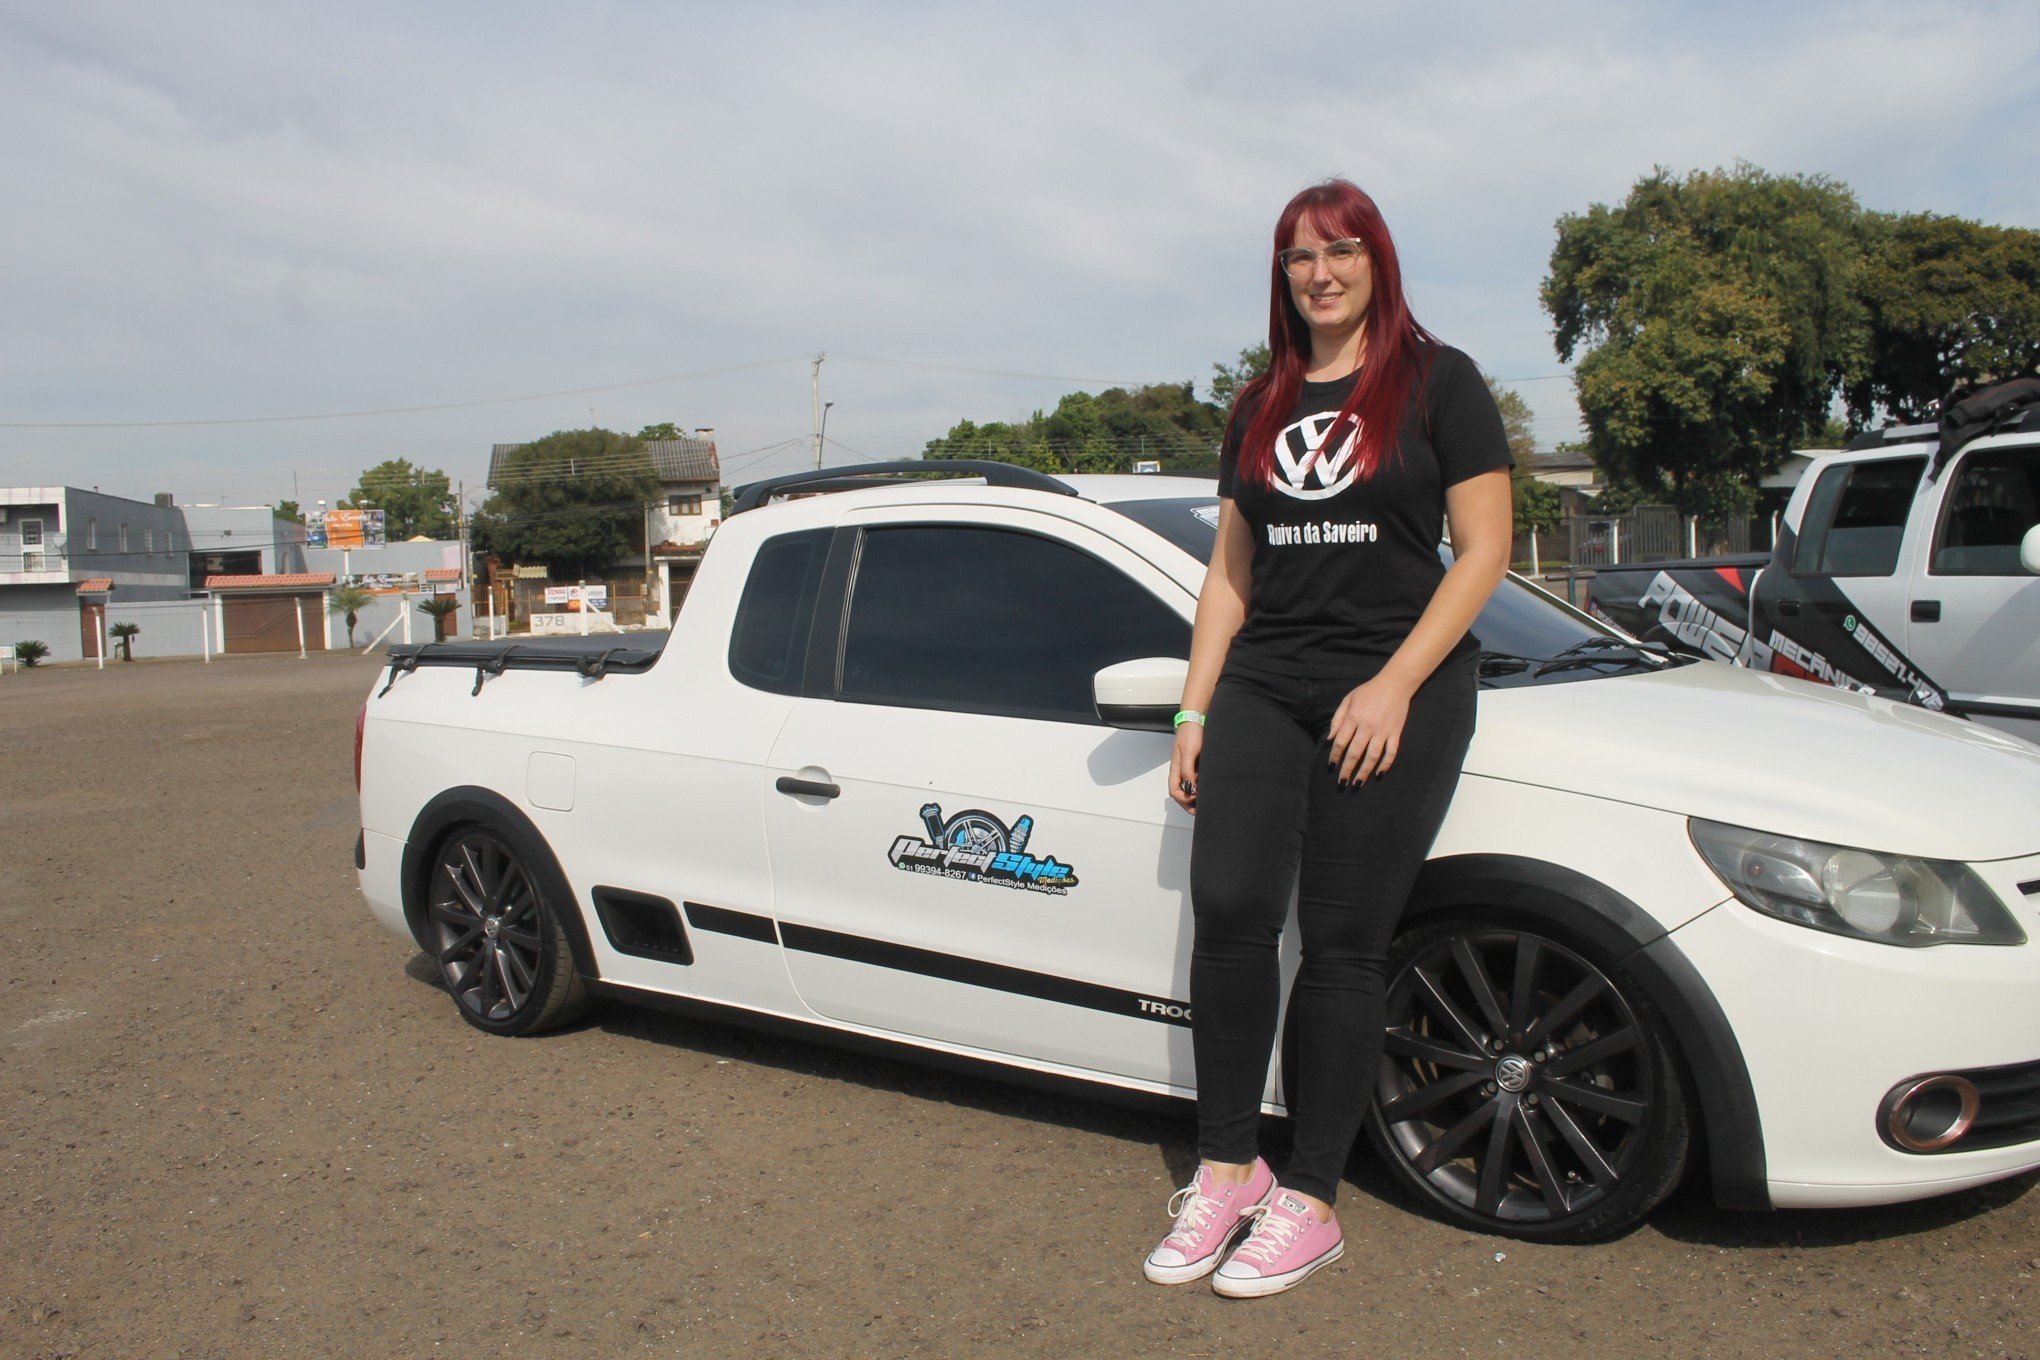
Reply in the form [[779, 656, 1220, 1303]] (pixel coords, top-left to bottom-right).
[[1189, 659, 1475, 1203]]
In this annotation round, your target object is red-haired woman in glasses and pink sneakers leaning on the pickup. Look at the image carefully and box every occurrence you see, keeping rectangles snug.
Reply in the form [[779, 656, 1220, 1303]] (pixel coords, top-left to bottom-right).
[[1144, 179, 1512, 1297]]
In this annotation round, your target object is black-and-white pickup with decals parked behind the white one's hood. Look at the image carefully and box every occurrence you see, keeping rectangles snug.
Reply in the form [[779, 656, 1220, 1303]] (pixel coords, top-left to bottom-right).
[[1589, 377, 2040, 742]]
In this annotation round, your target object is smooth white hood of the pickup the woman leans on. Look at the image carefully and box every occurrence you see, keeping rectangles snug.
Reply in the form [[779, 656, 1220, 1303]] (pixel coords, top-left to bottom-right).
[[1467, 661, 2040, 860]]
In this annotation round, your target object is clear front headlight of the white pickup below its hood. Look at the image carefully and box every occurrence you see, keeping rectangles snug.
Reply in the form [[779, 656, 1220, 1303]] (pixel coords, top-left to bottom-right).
[[1687, 818, 2026, 948]]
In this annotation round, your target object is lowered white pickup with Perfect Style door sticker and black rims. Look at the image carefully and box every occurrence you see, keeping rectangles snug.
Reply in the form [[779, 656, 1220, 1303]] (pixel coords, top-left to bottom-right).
[[357, 463, 2040, 1240]]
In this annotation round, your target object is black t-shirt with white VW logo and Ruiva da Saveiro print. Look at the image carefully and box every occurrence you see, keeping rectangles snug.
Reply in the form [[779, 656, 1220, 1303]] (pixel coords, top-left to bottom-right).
[[1218, 345, 1514, 677]]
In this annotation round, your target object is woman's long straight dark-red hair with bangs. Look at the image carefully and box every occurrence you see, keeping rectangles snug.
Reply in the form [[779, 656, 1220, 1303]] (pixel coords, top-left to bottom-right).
[[1226, 179, 1436, 485]]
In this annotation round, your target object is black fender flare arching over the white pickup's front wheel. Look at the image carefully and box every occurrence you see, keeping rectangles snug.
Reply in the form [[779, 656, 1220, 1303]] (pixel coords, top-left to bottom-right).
[[1401, 854, 1771, 1209]]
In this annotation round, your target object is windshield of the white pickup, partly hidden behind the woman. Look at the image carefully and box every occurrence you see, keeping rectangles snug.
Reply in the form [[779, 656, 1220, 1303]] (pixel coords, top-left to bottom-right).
[[1110, 498, 1659, 687]]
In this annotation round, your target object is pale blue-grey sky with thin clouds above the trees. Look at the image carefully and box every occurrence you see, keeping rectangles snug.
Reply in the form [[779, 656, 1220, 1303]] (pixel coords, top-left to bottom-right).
[[0, 0, 2040, 508]]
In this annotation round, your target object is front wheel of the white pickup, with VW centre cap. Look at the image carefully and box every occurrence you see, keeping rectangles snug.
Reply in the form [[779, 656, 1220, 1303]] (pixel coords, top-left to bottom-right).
[[1367, 913, 1691, 1242]]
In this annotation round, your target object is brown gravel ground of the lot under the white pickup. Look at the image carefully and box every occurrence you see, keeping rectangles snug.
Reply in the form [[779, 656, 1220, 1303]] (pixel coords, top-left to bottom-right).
[[0, 657, 2040, 1360]]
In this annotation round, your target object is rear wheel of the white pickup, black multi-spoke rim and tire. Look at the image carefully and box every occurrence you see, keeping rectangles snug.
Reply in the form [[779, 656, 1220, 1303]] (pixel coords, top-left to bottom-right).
[[424, 826, 588, 1034]]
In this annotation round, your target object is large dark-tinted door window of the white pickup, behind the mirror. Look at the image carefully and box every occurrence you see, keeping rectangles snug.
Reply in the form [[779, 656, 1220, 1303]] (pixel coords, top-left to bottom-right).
[[840, 524, 1189, 722]]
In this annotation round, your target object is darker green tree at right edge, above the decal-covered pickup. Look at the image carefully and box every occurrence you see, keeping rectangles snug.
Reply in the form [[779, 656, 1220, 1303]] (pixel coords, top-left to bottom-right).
[[1846, 212, 2040, 428]]
